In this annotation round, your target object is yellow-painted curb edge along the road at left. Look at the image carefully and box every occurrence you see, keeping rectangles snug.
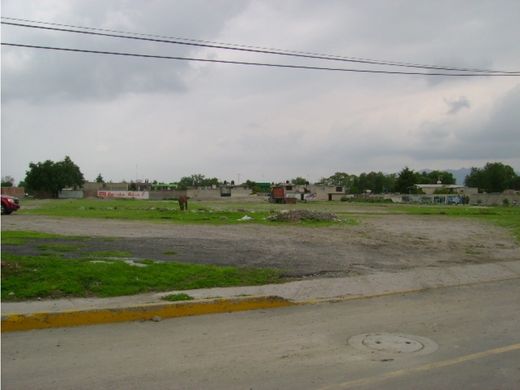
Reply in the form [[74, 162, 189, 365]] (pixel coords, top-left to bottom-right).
[[2, 297, 296, 332]]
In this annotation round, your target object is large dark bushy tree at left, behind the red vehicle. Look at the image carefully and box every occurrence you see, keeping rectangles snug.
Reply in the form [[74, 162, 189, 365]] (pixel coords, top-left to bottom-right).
[[25, 156, 85, 198]]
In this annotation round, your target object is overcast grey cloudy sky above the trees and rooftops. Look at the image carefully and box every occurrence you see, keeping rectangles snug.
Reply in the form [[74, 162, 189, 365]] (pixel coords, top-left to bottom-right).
[[1, 0, 520, 181]]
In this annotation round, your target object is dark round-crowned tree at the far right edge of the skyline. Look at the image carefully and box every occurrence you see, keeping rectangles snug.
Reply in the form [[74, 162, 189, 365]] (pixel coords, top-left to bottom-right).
[[464, 162, 518, 192]]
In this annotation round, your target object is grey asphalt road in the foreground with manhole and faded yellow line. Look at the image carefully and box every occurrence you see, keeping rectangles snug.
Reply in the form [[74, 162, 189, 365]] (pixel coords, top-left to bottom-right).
[[2, 279, 520, 389]]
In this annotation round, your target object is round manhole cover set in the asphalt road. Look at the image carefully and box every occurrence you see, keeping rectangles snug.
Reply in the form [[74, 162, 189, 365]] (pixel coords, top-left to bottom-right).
[[348, 333, 437, 354]]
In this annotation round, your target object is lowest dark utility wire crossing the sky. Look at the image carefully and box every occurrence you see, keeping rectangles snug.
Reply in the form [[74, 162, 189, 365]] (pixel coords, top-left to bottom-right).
[[2, 42, 520, 77]]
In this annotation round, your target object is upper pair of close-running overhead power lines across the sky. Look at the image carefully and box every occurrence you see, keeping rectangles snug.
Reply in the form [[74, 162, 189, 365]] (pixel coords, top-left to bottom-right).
[[1, 16, 520, 74]]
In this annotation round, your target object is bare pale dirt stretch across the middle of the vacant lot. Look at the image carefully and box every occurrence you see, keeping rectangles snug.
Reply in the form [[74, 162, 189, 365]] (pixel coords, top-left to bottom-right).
[[2, 215, 520, 277]]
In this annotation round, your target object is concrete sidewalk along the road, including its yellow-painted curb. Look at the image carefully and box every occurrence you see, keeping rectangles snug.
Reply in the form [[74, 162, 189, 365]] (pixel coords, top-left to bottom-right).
[[2, 260, 520, 332]]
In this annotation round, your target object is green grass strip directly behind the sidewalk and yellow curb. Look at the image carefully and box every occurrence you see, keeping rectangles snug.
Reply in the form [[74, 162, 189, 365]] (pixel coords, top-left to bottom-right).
[[2, 253, 281, 301]]
